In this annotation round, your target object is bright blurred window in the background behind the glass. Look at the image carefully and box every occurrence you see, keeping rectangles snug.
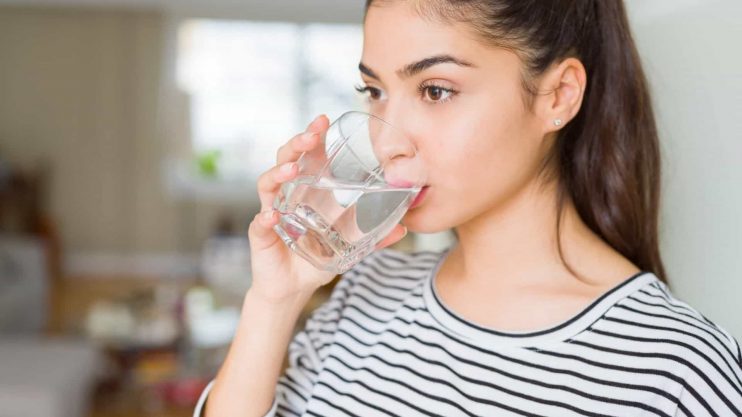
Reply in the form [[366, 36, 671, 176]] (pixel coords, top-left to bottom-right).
[[177, 20, 364, 181]]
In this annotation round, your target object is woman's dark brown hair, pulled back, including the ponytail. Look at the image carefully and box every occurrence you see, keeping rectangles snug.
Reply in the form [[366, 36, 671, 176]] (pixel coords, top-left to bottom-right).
[[366, 0, 667, 282]]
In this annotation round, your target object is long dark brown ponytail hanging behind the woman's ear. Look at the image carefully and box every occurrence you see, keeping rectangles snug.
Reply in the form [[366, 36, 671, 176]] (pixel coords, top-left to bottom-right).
[[553, 0, 667, 282]]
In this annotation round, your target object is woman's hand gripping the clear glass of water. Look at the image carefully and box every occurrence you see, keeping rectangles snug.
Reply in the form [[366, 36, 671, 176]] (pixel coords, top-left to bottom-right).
[[248, 115, 407, 301]]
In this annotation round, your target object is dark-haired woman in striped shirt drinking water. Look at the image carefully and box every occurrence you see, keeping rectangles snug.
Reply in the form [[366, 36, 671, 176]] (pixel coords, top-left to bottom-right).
[[196, 0, 742, 417]]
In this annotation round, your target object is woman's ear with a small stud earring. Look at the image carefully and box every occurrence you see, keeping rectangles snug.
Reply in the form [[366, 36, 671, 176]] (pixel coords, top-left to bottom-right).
[[536, 58, 587, 134]]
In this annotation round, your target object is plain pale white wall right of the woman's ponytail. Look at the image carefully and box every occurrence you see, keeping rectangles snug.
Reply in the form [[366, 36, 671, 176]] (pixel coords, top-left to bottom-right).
[[629, 0, 742, 338]]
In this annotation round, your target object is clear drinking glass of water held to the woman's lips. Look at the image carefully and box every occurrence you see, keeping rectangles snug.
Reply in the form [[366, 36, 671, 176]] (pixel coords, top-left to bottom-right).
[[273, 111, 426, 274]]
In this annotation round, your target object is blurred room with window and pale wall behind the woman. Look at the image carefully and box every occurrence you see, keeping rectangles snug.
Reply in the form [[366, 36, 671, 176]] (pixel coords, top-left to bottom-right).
[[0, 0, 742, 417]]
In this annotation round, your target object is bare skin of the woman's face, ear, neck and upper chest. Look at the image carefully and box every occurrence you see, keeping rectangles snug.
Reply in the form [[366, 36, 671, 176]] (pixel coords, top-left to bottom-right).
[[361, 2, 639, 331]]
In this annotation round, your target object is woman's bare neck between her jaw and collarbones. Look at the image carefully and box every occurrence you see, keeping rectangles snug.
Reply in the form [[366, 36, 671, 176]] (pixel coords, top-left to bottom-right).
[[446, 177, 610, 290]]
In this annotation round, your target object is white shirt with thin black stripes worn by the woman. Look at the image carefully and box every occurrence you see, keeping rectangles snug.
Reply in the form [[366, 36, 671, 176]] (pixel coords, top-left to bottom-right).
[[195, 249, 742, 417]]
